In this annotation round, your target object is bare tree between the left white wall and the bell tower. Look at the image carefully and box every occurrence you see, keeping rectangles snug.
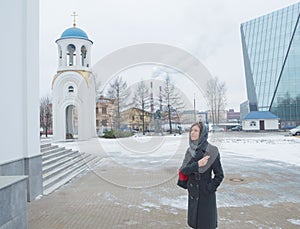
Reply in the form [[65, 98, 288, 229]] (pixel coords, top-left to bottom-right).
[[40, 96, 52, 137]]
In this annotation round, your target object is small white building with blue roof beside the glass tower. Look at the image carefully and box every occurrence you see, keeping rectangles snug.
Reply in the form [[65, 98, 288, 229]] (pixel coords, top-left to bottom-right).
[[242, 111, 279, 131]]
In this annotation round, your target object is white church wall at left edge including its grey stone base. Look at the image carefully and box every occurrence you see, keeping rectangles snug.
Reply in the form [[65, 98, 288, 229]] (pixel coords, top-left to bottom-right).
[[0, 0, 43, 228]]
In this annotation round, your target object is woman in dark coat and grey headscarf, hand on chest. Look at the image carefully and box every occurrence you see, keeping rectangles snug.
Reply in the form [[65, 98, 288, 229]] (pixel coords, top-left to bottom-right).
[[177, 123, 224, 229]]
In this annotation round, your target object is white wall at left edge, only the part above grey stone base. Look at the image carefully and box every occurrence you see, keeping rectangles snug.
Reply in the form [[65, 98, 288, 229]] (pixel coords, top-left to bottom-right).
[[0, 0, 40, 164]]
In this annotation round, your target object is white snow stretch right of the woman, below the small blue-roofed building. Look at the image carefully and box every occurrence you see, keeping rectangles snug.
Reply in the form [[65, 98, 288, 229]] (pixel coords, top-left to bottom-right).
[[210, 132, 300, 166]]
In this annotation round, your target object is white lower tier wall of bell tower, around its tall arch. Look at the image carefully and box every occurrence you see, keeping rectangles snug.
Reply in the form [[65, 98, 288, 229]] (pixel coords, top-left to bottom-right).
[[52, 71, 96, 141]]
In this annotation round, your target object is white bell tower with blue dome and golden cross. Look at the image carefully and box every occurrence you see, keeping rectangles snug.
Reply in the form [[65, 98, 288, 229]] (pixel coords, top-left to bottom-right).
[[52, 12, 96, 140]]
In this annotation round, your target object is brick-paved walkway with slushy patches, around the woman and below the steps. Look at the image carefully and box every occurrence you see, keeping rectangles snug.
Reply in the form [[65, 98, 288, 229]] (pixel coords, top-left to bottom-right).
[[28, 135, 300, 229]]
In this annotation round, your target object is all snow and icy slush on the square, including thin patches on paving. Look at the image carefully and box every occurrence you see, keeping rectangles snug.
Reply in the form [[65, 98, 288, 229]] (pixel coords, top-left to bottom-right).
[[38, 132, 300, 228]]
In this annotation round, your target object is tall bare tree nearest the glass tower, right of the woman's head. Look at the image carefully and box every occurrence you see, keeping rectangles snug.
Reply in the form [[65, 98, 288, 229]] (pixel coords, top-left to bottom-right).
[[205, 77, 226, 124]]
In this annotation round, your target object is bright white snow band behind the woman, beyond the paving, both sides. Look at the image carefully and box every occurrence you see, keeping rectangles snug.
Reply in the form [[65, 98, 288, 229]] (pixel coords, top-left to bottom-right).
[[58, 132, 300, 168]]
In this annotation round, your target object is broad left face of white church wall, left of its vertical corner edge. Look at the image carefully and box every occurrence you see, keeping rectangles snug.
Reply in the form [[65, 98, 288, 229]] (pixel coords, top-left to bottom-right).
[[0, 0, 25, 164]]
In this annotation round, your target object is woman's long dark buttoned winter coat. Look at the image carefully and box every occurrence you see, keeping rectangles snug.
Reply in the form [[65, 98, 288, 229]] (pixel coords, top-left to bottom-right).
[[181, 144, 224, 229]]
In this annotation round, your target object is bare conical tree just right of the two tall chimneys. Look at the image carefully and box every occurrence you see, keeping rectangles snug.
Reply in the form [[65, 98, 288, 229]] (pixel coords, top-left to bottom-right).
[[162, 74, 185, 134]]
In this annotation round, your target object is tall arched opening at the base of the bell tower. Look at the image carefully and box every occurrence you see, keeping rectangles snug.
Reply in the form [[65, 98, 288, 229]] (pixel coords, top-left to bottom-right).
[[66, 105, 78, 139]]
